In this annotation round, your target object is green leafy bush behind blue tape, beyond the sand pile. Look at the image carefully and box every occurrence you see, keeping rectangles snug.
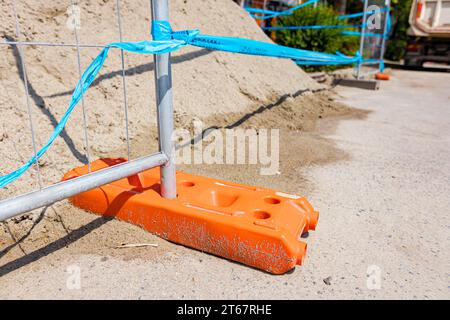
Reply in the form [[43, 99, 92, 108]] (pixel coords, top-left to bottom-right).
[[276, 4, 359, 70]]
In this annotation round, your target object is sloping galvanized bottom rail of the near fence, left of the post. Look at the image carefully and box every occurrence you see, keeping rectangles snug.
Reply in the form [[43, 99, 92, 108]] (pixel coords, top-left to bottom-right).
[[0, 152, 168, 221]]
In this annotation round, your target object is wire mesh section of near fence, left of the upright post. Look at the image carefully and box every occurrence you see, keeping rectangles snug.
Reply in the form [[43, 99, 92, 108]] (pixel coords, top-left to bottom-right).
[[0, 0, 171, 220]]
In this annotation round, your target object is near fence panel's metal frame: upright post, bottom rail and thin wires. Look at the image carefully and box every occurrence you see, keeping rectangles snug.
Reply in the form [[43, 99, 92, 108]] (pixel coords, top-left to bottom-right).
[[0, 0, 176, 221]]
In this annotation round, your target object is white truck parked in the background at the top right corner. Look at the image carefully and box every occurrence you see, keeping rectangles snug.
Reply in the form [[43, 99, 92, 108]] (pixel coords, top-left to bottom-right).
[[405, 0, 450, 67]]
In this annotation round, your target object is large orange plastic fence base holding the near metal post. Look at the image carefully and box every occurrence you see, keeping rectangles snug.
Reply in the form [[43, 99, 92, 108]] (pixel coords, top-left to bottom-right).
[[63, 158, 319, 274]]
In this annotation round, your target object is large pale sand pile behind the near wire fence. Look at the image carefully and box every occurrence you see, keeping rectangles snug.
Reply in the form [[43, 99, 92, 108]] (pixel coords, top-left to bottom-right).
[[0, 0, 324, 198]]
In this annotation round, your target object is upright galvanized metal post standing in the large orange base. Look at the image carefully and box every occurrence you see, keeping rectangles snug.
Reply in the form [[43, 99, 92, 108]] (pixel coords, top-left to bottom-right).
[[151, 0, 177, 199]]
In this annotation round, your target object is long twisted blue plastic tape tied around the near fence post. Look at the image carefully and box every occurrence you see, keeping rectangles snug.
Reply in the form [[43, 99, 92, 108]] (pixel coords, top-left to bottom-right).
[[0, 21, 361, 189]]
